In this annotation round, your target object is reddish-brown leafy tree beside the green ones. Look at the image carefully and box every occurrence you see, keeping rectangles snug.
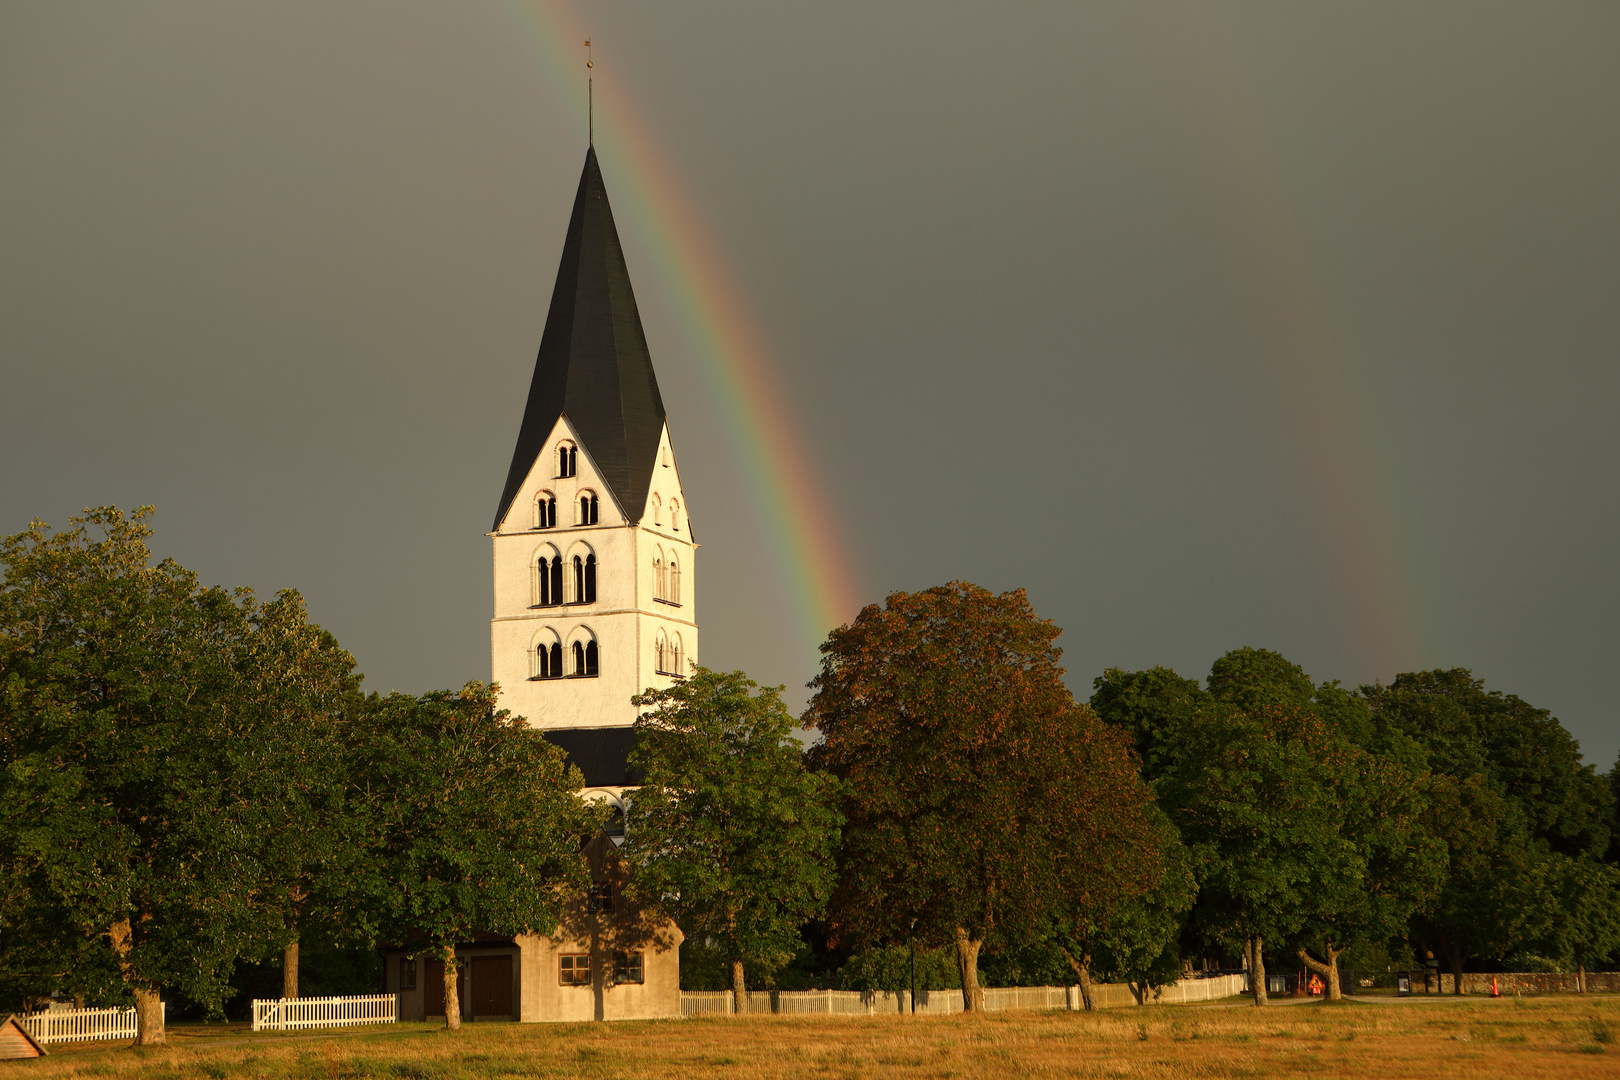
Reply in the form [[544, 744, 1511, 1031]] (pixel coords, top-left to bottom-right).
[[805, 581, 1160, 1010]]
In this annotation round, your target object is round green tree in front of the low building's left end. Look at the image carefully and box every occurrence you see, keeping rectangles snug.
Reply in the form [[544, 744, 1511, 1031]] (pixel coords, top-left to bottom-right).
[[356, 682, 603, 1028]]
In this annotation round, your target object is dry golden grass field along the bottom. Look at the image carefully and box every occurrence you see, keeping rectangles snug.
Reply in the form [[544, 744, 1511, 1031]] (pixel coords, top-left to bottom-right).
[[0, 996, 1620, 1080]]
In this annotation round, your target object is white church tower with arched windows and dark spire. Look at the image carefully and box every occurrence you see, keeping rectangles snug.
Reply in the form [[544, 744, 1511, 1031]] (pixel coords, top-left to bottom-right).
[[489, 147, 698, 767]]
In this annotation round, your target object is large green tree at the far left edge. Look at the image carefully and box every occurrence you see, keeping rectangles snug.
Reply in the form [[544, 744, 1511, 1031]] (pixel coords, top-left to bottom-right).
[[0, 507, 264, 1044]]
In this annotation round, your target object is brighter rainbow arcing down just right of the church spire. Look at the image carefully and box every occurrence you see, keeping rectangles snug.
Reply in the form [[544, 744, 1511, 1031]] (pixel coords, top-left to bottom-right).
[[504, 0, 862, 654]]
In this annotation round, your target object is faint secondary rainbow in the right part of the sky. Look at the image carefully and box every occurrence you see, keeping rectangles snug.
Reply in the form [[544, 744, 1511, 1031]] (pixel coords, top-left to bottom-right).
[[1132, 5, 1439, 680]]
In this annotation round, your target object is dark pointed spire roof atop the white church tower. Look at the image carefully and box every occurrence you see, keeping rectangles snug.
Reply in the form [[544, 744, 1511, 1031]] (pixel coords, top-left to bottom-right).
[[494, 147, 664, 528]]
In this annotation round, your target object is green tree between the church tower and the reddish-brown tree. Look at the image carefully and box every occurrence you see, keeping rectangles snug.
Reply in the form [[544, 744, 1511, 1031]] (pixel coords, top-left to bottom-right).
[[622, 667, 841, 1012]]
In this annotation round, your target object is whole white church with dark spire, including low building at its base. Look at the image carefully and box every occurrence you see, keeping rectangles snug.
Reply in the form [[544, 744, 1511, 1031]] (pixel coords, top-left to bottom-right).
[[384, 147, 698, 1022]]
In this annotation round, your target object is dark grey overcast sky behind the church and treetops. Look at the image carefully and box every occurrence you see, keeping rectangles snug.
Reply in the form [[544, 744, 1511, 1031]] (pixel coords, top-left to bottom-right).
[[0, 0, 1620, 767]]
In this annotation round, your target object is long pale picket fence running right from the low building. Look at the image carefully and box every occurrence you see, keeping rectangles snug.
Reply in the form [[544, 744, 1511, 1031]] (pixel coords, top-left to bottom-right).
[[680, 975, 1246, 1017]]
